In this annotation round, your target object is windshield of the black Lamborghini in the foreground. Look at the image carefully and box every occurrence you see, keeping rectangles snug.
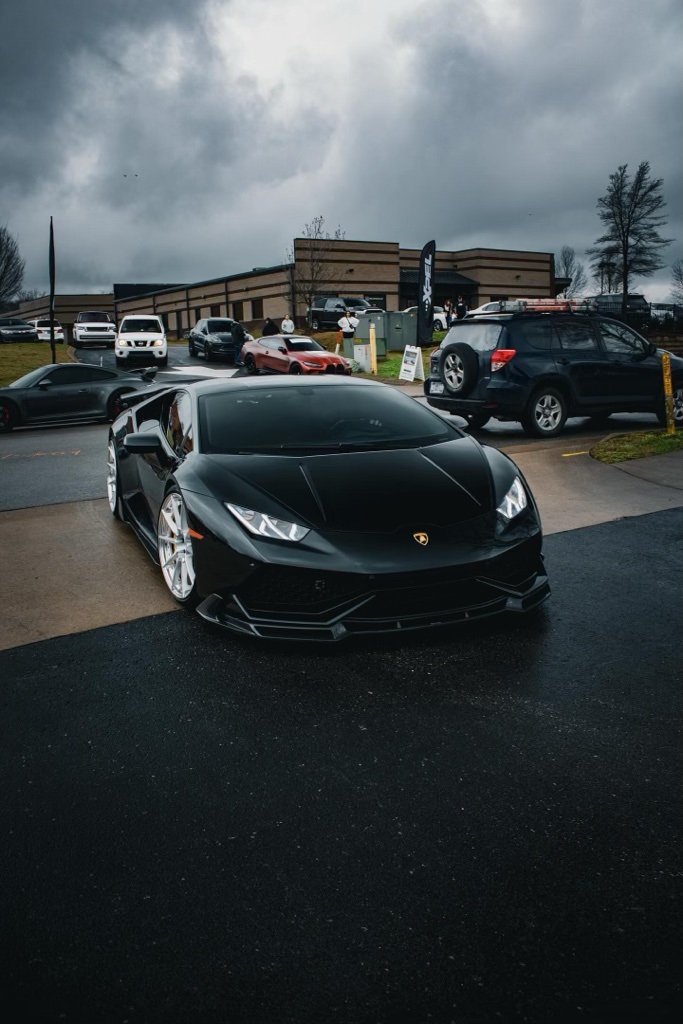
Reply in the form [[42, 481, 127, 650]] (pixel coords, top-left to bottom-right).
[[199, 384, 462, 455]]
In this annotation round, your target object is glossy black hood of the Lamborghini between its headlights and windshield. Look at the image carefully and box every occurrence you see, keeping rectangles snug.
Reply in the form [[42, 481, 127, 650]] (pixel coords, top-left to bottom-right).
[[184, 437, 494, 534]]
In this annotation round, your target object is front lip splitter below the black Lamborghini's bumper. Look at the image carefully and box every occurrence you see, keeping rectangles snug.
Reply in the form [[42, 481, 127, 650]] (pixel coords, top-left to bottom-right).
[[197, 574, 550, 643]]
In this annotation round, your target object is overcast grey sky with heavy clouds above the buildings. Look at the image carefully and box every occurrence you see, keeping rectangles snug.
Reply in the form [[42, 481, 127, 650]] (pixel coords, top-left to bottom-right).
[[0, 0, 683, 300]]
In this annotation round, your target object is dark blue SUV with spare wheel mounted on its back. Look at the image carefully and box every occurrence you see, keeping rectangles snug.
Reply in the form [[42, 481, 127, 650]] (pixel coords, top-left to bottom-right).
[[425, 312, 683, 437]]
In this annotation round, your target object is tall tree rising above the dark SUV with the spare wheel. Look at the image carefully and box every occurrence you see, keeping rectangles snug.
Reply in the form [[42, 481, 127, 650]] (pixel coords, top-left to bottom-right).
[[586, 160, 672, 314]]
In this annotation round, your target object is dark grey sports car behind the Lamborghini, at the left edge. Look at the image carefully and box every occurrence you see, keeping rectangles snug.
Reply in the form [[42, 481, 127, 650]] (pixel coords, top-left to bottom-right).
[[0, 362, 154, 433]]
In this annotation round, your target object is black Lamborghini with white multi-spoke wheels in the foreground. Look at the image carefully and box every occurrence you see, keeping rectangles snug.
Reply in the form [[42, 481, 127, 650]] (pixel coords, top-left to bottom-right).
[[106, 376, 549, 641]]
